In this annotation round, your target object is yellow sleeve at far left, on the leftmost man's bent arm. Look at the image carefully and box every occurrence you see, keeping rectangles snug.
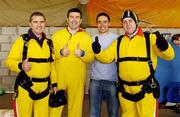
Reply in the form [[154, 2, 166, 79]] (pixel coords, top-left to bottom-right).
[[5, 37, 24, 72]]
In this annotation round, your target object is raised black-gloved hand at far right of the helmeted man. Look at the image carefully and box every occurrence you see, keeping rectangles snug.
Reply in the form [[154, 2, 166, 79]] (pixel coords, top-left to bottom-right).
[[153, 31, 168, 51]]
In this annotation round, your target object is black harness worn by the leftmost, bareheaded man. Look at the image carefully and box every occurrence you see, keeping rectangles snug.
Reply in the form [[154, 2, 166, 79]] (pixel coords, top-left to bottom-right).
[[14, 34, 54, 100]]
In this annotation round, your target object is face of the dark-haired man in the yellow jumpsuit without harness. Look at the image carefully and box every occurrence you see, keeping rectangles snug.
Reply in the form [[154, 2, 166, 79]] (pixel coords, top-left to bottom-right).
[[67, 12, 82, 30]]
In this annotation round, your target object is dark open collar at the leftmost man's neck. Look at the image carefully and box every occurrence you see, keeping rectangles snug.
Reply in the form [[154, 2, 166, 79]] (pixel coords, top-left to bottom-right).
[[28, 29, 46, 47]]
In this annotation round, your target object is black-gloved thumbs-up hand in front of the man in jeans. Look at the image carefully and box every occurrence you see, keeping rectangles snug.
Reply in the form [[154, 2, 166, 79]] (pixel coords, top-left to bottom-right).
[[92, 36, 101, 54]]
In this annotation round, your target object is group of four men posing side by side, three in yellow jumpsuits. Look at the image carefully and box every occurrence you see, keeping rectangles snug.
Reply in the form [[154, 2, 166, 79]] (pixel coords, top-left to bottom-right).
[[6, 8, 174, 117]]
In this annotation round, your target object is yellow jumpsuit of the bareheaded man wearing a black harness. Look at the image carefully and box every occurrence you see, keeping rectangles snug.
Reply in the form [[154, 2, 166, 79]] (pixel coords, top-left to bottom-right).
[[5, 36, 57, 117]]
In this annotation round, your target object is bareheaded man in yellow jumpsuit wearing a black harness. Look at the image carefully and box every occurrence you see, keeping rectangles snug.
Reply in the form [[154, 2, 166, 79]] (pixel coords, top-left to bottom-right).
[[5, 12, 57, 117]]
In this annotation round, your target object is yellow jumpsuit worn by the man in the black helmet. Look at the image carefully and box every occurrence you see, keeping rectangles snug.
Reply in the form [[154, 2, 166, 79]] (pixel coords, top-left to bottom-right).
[[96, 28, 174, 117]]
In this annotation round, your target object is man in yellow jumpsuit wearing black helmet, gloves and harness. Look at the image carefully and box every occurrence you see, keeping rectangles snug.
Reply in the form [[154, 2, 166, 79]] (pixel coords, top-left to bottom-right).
[[92, 10, 174, 117]]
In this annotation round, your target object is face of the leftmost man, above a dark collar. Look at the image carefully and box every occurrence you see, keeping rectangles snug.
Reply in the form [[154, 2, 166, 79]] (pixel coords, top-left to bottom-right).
[[29, 16, 46, 37]]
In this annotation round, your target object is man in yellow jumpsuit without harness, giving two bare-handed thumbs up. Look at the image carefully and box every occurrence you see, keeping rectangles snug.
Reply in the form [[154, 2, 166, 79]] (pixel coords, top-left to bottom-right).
[[50, 8, 94, 117]]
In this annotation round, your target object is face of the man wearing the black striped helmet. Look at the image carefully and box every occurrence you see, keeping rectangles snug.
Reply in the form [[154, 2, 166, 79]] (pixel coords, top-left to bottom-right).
[[122, 18, 136, 35]]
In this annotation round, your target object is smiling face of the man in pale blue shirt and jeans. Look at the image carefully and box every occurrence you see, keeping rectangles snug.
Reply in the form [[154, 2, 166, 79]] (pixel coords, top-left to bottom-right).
[[96, 15, 110, 34]]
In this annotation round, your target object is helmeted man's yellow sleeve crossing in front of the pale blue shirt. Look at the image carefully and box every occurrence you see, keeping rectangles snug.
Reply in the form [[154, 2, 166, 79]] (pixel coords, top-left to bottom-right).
[[95, 40, 117, 63]]
